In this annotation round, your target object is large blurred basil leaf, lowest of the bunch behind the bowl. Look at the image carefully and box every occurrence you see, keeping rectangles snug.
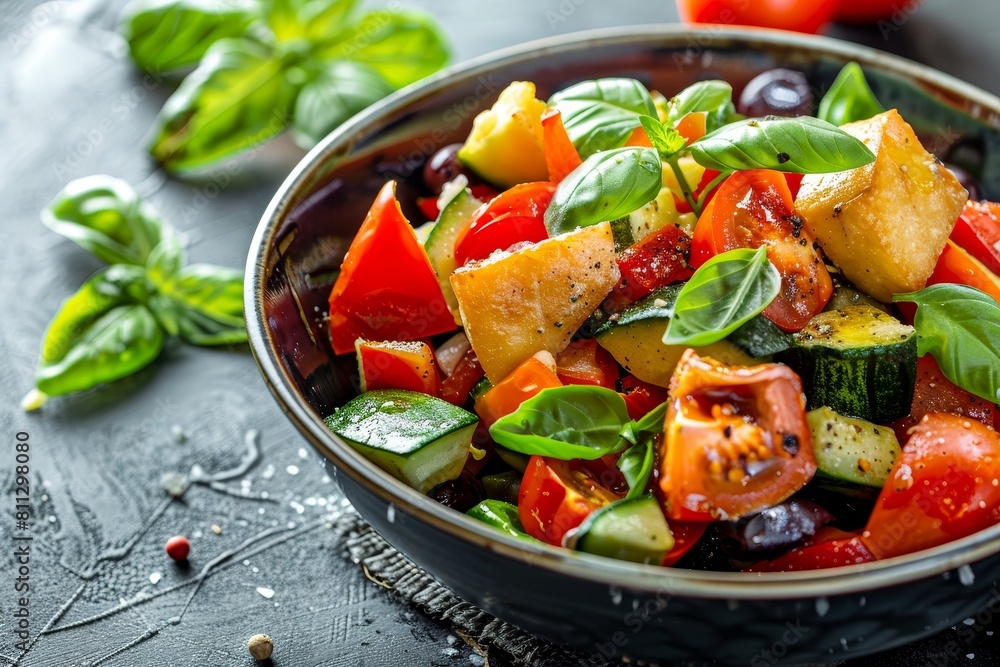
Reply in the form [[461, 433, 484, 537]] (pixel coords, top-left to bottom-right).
[[149, 39, 296, 171]]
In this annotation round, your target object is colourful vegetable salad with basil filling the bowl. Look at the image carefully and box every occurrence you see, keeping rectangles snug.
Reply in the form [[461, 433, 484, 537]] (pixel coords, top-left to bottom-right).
[[318, 63, 1000, 571]]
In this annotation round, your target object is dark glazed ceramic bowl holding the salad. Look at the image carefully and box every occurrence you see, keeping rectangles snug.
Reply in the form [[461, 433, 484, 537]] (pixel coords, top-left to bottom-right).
[[246, 25, 1000, 666]]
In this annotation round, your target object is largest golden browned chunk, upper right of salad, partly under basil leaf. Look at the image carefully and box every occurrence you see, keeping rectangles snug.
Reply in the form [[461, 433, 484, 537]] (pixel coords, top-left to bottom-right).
[[795, 109, 968, 302]]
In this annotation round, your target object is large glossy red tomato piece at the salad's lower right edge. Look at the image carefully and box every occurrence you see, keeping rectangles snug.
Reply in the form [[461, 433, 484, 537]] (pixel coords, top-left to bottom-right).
[[861, 412, 1000, 558]]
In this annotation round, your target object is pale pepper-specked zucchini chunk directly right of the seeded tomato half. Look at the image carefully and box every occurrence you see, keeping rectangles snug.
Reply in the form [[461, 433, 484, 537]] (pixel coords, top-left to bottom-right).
[[806, 406, 901, 490]]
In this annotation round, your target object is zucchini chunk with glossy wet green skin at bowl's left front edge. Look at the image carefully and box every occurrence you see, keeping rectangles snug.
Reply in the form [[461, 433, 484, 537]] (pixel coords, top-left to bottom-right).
[[323, 389, 479, 493]]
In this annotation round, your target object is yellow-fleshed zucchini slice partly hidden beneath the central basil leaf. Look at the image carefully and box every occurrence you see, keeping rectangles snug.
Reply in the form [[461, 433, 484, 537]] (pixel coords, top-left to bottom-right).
[[594, 285, 759, 387]]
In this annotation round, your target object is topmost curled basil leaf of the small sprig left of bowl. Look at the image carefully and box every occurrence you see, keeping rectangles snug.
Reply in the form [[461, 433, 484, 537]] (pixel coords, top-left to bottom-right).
[[42, 176, 174, 265]]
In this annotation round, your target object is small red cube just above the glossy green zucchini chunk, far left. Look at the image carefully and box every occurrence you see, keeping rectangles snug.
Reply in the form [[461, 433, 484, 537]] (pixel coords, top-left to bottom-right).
[[357, 340, 440, 396]]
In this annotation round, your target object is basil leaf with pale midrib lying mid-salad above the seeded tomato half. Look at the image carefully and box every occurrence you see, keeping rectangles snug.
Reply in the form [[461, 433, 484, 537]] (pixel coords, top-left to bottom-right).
[[663, 245, 781, 346]]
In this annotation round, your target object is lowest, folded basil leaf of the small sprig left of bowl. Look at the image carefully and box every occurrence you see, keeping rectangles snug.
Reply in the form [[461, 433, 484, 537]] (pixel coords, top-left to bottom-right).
[[35, 265, 163, 396]]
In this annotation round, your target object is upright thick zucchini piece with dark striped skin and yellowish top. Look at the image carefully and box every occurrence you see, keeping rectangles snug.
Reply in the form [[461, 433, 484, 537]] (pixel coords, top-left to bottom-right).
[[779, 305, 917, 424]]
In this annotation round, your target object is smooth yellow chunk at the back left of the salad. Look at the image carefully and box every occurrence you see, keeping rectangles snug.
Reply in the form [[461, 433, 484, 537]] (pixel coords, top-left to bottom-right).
[[458, 81, 549, 189]]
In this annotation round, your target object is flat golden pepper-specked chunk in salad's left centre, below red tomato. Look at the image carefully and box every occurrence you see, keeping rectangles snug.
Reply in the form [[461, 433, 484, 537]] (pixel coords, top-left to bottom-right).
[[451, 222, 619, 383]]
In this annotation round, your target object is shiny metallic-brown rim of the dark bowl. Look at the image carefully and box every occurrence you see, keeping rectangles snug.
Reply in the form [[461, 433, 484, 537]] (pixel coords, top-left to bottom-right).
[[244, 24, 1000, 600]]
